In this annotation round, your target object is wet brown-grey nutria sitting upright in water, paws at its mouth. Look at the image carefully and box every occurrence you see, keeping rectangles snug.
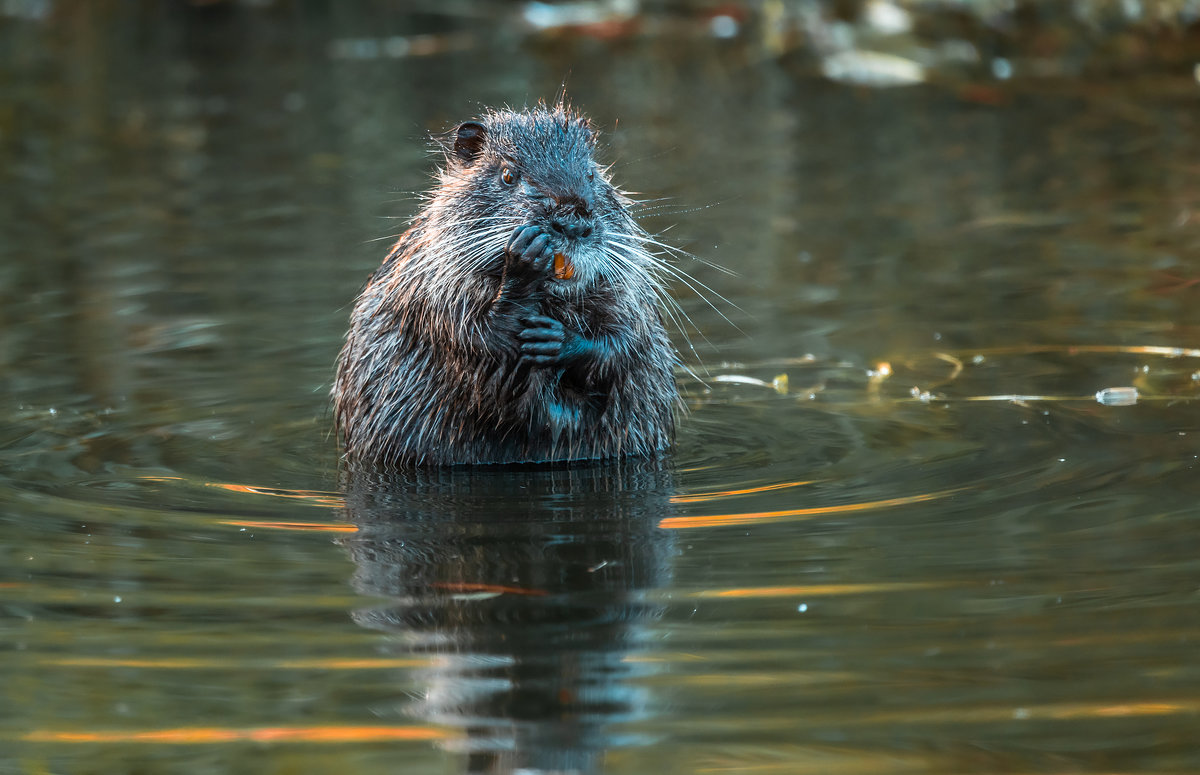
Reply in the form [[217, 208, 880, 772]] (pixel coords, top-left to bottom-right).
[[334, 103, 678, 467]]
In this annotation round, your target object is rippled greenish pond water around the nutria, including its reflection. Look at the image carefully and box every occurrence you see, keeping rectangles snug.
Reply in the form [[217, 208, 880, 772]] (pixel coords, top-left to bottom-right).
[[0, 4, 1200, 774]]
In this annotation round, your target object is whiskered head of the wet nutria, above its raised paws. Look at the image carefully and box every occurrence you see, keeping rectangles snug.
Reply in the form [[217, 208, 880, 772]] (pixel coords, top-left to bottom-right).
[[430, 104, 653, 298]]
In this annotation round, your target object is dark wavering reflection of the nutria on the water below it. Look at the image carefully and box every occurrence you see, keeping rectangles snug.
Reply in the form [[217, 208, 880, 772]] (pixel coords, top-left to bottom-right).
[[347, 461, 672, 773]]
